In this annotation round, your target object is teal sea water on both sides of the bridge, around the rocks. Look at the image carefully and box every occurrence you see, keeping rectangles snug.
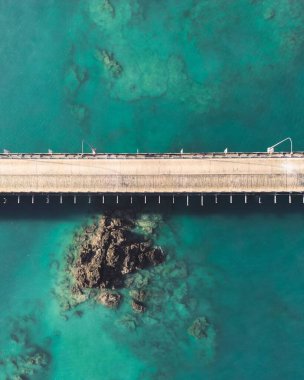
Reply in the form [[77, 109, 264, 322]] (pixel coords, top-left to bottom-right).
[[0, 0, 304, 380]]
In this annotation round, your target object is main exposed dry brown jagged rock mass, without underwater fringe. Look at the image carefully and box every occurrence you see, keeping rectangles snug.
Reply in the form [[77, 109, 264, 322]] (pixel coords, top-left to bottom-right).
[[73, 214, 165, 290]]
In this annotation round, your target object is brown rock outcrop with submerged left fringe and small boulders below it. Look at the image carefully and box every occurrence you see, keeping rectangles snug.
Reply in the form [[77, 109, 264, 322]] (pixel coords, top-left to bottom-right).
[[55, 212, 165, 312]]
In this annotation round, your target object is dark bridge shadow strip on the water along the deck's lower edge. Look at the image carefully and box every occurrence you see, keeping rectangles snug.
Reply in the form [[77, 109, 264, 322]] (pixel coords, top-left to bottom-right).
[[0, 194, 304, 220]]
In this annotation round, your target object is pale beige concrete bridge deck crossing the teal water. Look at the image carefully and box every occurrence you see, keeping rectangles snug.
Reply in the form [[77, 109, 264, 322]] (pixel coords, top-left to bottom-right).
[[0, 152, 304, 194]]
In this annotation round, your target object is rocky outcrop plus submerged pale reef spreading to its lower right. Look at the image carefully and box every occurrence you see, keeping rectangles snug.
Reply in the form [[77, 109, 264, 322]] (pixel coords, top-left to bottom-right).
[[53, 211, 216, 373]]
